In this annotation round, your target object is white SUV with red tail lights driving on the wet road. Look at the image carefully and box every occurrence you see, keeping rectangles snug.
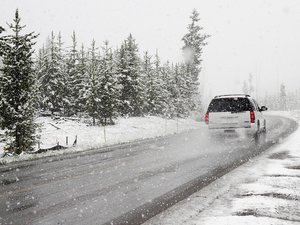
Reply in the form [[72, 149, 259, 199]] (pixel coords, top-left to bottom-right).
[[205, 94, 268, 135]]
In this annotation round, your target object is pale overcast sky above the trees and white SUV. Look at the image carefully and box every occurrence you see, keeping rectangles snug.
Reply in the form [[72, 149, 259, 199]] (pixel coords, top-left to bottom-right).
[[0, 0, 300, 103]]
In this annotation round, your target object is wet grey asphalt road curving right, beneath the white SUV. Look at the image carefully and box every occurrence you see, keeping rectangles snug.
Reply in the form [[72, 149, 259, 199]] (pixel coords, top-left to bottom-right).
[[0, 116, 297, 225]]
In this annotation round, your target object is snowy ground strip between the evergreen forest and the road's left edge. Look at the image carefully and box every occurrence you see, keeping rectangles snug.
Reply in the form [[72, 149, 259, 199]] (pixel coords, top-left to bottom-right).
[[0, 116, 205, 164]]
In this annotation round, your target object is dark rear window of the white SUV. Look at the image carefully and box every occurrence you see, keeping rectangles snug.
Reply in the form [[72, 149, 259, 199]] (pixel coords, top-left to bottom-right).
[[208, 98, 253, 112]]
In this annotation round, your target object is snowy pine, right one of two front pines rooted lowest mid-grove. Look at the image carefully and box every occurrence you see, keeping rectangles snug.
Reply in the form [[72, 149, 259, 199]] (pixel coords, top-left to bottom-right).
[[98, 41, 119, 126]]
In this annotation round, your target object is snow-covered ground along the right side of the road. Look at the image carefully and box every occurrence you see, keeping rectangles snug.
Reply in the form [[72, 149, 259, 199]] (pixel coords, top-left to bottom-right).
[[145, 111, 300, 225]]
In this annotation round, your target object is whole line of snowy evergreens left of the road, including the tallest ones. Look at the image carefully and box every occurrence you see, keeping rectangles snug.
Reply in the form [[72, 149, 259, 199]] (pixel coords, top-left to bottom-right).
[[0, 10, 208, 154]]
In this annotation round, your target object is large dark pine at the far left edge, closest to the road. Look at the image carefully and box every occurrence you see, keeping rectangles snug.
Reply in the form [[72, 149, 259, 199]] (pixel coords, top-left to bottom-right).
[[0, 10, 37, 154]]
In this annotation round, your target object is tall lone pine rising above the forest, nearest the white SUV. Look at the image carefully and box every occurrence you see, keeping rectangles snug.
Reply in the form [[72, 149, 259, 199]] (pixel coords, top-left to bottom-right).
[[182, 9, 209, 110]]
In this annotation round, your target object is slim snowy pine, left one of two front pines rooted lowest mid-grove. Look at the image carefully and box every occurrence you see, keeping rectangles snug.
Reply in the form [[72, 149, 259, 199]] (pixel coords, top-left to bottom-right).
[[84, 40, 101, 126]]
